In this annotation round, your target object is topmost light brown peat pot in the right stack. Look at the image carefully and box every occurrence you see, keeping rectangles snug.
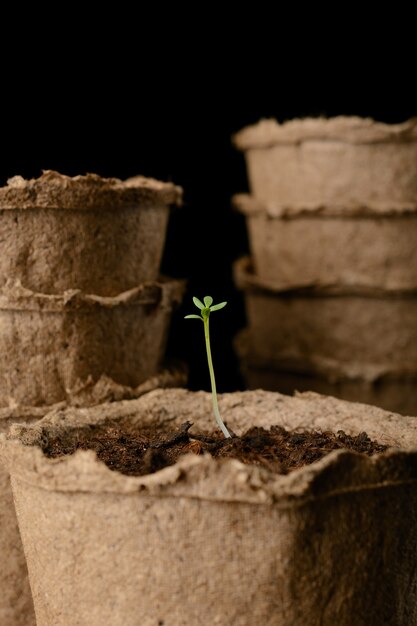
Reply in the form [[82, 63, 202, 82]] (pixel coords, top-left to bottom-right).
[[234, 117, 417, 212]]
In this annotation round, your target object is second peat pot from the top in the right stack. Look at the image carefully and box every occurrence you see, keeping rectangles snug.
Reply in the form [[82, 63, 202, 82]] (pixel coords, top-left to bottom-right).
[[233, 193, 417, 289]]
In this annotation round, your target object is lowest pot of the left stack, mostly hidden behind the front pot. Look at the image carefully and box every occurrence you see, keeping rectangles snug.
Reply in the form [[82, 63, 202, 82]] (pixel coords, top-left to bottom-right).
[[0, 365, 187, 626]]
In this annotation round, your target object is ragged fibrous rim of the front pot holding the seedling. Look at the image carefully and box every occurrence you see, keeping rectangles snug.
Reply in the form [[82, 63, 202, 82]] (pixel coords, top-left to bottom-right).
[[0, 389, 417, 507]]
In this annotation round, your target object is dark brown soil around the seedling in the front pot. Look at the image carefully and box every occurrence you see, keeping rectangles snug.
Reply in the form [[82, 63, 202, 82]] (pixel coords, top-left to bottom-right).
[[43, 422, 387, 476]]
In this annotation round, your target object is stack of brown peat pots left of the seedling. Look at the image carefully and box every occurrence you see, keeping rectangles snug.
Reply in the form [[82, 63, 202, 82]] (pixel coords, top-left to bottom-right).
[[0, 171, 184, 626]]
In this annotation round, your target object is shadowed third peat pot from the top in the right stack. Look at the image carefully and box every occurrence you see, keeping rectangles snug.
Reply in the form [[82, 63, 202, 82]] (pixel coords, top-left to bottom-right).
[[234, 258, 417, 380]]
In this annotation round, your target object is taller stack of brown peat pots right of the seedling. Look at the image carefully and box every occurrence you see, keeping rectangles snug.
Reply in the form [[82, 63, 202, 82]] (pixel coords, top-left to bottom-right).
[[233, 117, 417, 414]]
